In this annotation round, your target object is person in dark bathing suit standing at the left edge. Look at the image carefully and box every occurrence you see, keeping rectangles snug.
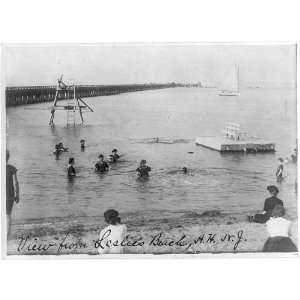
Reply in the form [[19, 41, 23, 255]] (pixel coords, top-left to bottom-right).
[[6, 150, 20, 236]]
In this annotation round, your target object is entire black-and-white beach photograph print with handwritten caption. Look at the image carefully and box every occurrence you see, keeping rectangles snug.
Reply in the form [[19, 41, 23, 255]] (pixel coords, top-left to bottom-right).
[[1, 43, 298, 259]]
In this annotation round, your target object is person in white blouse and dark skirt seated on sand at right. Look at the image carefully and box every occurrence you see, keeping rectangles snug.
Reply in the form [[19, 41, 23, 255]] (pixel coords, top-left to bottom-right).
[[263, 205, 297, 252]]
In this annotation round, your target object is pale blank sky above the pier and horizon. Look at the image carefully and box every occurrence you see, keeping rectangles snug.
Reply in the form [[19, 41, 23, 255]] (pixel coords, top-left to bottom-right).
[[3, 44, 296, 87]]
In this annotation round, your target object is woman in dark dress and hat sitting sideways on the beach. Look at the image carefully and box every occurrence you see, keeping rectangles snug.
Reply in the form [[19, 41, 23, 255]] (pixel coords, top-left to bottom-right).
[[249, 185, 283, 223]]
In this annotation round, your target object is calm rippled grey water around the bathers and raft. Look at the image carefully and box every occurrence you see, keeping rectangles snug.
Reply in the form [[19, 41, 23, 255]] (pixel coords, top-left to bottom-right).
[[7, 88, 296, 222]]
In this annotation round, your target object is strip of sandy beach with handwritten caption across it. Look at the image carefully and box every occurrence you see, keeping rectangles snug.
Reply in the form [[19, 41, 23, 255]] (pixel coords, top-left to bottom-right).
[[8, 211, 297, 255]]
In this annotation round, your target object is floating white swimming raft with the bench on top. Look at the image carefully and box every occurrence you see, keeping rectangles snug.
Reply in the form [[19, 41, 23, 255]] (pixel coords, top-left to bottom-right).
[[195, 123, 275, 153]]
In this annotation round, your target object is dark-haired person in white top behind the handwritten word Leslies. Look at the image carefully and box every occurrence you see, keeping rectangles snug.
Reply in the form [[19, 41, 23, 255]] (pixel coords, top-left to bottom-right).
[[98, 209, 127, 254]]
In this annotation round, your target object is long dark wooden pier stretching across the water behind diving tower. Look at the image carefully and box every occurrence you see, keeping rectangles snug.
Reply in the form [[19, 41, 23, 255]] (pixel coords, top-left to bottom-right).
[[5, 83, 181, 107]]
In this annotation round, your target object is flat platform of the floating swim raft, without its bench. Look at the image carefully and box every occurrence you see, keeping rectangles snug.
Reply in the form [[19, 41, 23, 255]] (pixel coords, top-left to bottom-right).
[[196, 136, 275, 152]]
